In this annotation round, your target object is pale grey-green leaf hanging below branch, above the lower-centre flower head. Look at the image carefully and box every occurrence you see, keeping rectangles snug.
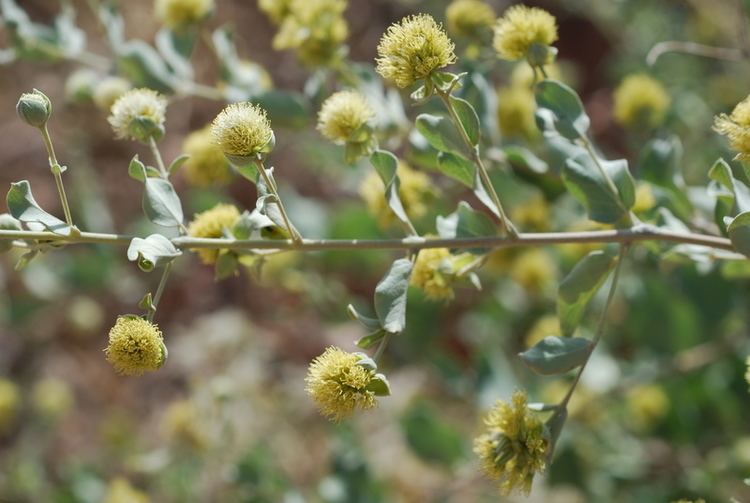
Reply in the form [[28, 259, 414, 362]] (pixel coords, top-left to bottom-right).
[[375, 258, 412, 333]]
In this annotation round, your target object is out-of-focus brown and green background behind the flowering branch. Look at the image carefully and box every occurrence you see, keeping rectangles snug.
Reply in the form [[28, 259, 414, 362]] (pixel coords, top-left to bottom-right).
[[0, 0, 750, 503]]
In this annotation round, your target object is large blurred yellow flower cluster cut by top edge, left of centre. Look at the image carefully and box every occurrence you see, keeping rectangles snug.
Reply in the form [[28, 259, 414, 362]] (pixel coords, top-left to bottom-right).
[[273, 0, 349, 66]]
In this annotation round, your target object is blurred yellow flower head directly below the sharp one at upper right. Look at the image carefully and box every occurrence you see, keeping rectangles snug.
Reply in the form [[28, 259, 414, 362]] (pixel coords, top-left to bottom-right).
[[497, 86, 539, 140]]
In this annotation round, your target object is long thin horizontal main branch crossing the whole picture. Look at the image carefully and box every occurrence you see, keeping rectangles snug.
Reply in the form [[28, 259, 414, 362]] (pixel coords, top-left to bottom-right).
[[0, 225, 742, 258]]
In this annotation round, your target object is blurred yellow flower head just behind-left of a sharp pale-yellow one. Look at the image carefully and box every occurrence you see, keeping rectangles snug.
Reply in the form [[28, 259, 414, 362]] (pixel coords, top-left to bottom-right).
[[182, 127, 232, 187]]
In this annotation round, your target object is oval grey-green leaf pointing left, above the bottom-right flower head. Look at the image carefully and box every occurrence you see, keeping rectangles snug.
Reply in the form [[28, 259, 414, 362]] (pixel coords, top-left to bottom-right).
[[519, 335, 591, 375]]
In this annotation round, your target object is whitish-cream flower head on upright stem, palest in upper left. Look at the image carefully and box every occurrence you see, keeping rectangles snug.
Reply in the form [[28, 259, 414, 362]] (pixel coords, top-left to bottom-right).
[[108, 89, 167, 143]]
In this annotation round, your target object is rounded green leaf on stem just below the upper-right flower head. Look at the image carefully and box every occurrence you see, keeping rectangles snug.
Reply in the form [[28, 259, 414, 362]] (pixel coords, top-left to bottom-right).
[[534, 79, 591, 140]]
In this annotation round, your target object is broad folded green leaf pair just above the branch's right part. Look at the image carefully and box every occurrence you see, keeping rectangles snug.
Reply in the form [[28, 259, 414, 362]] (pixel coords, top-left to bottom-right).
[[563, 152, 635, 224]]
